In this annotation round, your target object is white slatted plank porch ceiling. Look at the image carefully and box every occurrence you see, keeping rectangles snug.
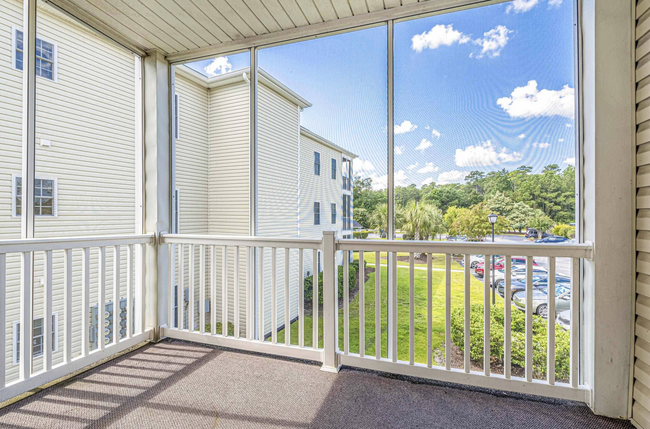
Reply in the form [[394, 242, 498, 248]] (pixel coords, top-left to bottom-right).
[[46, 0, 492, 60]]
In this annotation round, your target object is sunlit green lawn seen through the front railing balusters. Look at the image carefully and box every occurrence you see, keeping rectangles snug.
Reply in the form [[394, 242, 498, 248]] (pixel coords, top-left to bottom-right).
[[278, 259, 496, 363]]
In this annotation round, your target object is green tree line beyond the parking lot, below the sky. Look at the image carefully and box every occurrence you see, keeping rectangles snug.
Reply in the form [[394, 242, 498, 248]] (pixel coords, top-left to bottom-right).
[[353, 164, 575, 240]]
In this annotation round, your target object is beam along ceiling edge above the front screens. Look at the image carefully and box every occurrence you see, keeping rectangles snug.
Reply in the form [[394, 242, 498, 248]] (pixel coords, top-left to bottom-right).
[[166, 0, 508, 64]]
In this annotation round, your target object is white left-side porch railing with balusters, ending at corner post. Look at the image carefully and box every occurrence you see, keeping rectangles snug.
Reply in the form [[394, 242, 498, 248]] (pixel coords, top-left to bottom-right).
[[0, 235, 153, 402]]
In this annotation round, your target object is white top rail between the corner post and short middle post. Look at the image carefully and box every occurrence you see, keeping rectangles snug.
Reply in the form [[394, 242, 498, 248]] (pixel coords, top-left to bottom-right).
[[160, 234, 323, 249]]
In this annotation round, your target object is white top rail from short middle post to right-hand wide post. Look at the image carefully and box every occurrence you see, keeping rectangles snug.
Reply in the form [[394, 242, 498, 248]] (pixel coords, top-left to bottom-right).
[[337, 239, 593, 259]]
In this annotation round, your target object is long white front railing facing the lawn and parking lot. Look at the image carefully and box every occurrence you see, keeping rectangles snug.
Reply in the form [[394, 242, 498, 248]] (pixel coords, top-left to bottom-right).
[[160, 232, 593, 402]]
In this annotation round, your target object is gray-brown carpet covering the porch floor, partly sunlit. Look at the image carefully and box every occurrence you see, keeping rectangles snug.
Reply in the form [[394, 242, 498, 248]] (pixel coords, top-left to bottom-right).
[[0, 341, 632, 429]]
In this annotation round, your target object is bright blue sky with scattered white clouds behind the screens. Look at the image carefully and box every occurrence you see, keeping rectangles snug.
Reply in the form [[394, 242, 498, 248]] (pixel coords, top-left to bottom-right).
[[186, 0, 575, 188]]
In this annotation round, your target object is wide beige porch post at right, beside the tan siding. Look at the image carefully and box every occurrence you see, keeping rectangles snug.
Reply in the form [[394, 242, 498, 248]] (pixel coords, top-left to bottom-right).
[[572, 0, 635, 418]]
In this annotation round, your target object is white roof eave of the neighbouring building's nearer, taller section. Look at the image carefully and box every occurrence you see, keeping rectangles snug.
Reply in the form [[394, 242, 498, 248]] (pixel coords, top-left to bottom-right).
[[175, 65, 311, 108]]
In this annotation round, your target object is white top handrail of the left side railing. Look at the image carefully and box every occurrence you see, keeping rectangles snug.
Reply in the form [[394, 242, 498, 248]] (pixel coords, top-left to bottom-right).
[[0, 234, 154, 253]]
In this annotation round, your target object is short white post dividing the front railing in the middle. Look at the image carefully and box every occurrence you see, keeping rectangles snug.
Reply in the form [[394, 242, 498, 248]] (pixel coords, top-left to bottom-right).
[[322, 231, 340, 372]]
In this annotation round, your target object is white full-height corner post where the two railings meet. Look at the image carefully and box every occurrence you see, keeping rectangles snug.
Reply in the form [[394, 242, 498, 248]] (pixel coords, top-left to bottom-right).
[[144, 50, 172, 340]]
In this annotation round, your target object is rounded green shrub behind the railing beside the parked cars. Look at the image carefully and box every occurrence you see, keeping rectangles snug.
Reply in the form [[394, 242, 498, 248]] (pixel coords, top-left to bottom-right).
[[451, 304, 570, 380]]
